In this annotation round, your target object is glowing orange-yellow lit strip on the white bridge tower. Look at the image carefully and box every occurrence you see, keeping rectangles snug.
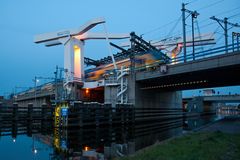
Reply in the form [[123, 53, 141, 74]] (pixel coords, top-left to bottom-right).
[[73, 45, 81, 78]]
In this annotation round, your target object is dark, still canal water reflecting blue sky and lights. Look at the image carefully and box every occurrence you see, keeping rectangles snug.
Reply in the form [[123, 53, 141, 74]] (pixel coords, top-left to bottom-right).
[[0, 111, 218, 160]]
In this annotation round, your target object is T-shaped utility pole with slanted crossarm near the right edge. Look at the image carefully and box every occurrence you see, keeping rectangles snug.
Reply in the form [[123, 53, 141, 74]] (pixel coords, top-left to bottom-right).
[[210, 16, 240, 53]]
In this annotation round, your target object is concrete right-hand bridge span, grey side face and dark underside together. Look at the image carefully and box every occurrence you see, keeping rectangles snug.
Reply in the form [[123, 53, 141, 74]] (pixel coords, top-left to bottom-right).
[[136, 54, 240, 91]]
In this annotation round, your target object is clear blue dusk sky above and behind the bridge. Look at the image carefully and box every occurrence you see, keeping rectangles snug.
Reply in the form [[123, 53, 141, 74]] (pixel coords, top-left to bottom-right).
[[0, 0, 240, 95]]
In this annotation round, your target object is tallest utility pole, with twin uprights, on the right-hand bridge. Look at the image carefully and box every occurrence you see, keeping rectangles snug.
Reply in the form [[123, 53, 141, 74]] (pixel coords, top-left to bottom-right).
[[182, 3, 199, 62]]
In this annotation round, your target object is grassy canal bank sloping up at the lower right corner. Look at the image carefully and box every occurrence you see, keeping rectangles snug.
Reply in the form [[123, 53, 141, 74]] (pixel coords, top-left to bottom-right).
[[121, 117, 240, 160]]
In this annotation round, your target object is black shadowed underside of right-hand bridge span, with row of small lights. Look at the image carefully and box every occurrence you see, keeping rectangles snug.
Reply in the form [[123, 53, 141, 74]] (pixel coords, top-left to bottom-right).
[[138, 65, 240, 90]]
